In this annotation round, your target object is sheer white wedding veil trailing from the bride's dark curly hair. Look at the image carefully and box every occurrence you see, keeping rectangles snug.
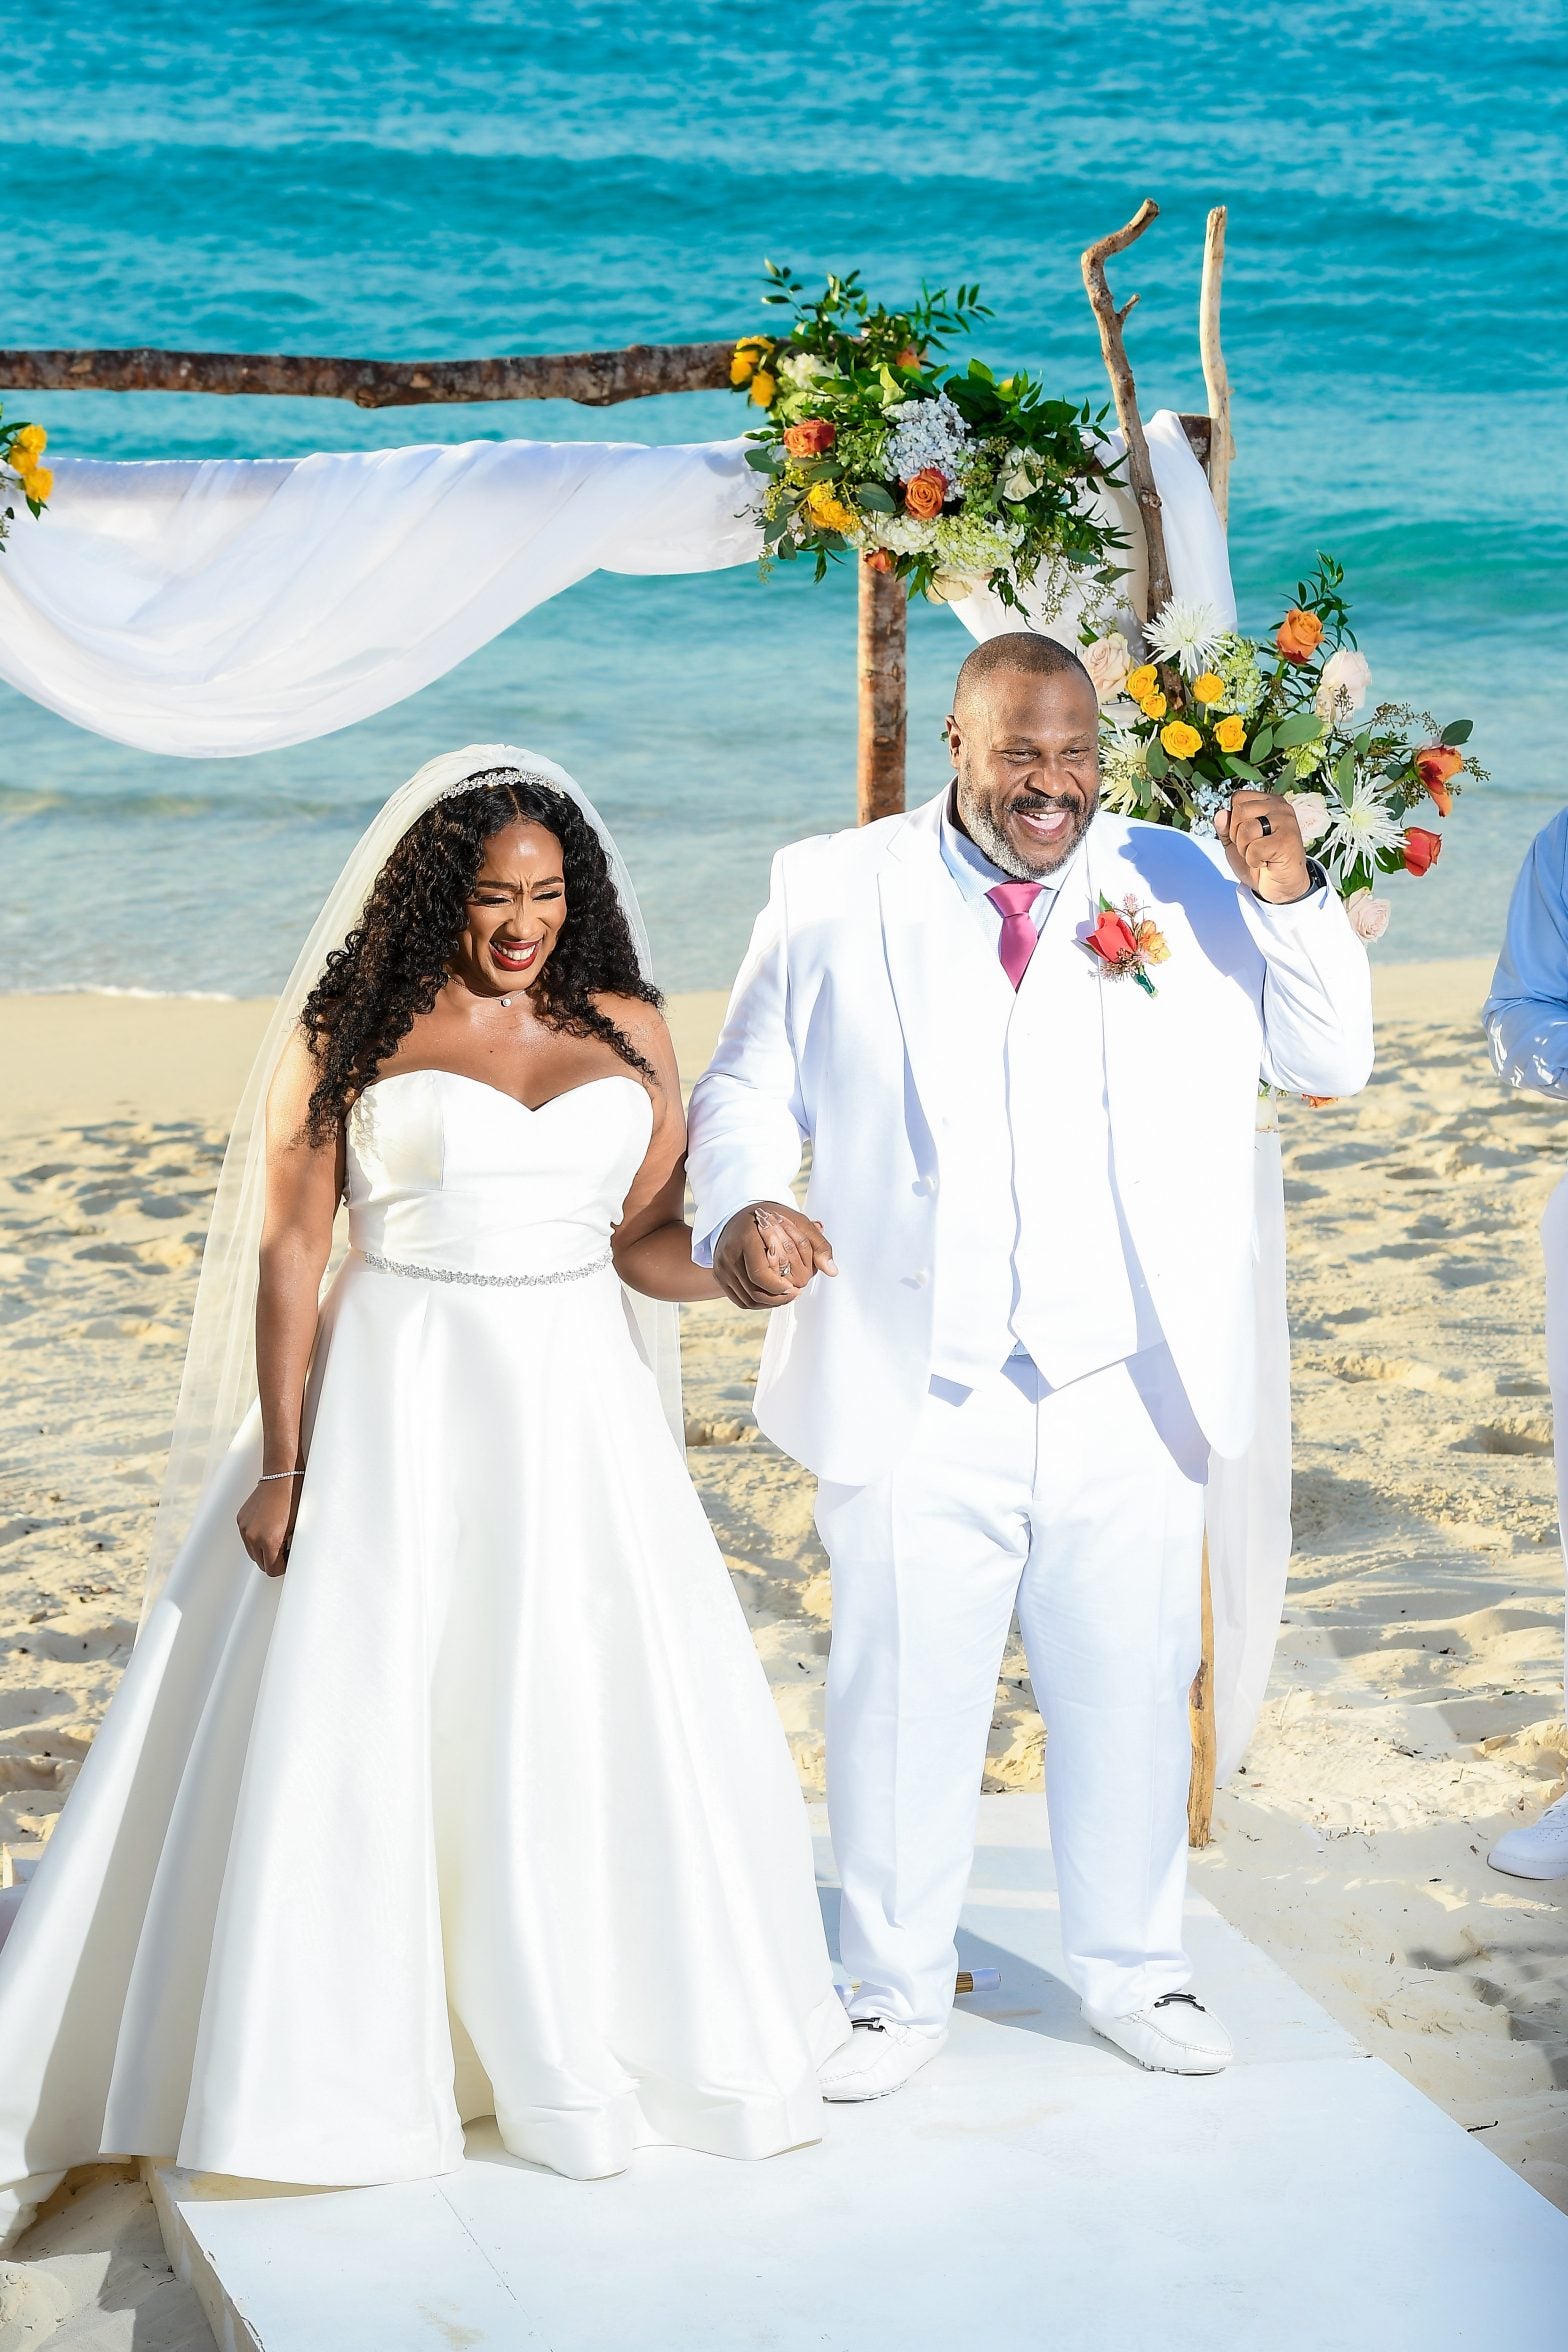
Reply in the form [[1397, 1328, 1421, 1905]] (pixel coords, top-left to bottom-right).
[[141, 743, 684, 1625]]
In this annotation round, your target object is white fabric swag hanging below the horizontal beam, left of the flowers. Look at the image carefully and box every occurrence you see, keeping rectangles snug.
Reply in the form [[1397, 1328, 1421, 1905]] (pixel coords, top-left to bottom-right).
[[0, 440, 759, 760]]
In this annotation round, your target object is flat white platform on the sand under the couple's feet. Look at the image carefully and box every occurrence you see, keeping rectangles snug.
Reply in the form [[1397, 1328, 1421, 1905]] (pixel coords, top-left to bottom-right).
[[153, 1797, 1568, 2352]]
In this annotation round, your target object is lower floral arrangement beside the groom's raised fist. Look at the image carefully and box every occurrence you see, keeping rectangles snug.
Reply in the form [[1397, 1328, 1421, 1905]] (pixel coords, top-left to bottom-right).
[[1084, 555, 1486, 941]]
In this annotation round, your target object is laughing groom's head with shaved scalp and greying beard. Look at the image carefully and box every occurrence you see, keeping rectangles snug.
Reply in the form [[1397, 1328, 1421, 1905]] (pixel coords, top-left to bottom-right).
[[947, 630, 1100, 882]]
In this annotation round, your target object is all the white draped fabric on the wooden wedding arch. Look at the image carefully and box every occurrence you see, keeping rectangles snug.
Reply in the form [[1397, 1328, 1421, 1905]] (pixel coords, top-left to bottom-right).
[[0, 409, 1291, 1771]]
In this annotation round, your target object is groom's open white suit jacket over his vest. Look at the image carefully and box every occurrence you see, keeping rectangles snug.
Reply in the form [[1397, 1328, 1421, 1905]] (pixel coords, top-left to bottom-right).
[[689, 793, 1373, 1484]]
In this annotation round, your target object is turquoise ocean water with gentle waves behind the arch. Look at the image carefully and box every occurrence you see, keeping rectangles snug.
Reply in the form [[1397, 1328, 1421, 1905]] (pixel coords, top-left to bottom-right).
[[0, 0, 1568, 993]]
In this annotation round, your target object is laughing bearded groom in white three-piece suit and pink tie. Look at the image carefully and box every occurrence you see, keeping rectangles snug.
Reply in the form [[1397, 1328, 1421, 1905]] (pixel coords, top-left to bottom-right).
[[689, 635, 1373, 2098]]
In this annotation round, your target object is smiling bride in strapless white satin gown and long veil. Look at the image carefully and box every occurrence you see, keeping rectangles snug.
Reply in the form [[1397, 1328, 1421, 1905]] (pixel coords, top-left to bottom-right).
[[0, 746, 849, 2225]]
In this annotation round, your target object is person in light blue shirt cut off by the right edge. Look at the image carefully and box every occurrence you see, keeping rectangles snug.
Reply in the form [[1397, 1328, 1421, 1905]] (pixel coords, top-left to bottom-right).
[[1481, 809, 1568, 1879]]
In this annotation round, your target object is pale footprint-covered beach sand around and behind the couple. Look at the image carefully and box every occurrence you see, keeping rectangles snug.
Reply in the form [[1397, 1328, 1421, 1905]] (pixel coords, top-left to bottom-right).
[[0, 962, 1568, 2347]]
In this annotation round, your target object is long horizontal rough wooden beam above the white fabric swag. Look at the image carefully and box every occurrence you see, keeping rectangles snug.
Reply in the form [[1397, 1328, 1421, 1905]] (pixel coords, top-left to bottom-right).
[[0, 341, 736, 409]]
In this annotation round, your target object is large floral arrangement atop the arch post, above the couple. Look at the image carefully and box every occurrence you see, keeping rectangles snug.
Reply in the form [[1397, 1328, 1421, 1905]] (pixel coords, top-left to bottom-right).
[[729, 261, 1124, 604]]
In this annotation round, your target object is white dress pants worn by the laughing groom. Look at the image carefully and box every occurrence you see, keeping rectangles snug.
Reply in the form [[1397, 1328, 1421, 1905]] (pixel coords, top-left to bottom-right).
[[816, 1345, 1208, 2027]]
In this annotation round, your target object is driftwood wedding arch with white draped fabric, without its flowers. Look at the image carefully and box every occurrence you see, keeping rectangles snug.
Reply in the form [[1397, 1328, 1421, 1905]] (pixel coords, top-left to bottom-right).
[[0, 200, 1260, 1844]]
